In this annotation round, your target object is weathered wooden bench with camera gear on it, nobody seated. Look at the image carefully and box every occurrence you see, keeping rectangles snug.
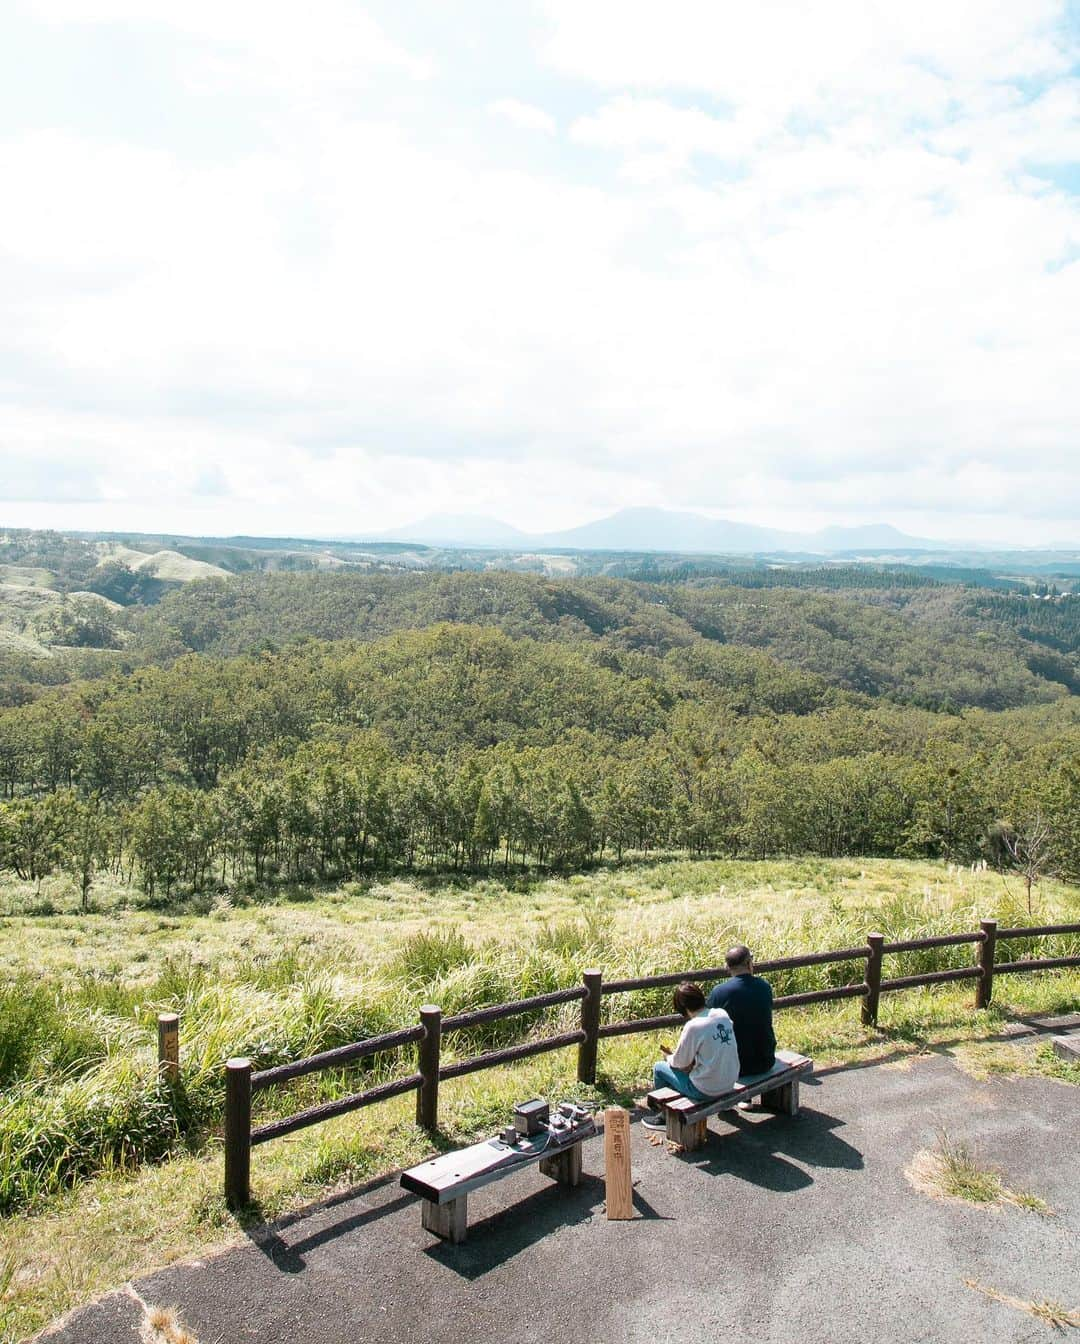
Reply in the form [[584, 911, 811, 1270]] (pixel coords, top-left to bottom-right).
[[402, 1120, 596, 1246]]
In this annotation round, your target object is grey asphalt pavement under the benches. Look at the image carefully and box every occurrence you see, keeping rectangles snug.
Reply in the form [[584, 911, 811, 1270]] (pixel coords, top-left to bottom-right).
[[48, 1021, 1080, 1344]]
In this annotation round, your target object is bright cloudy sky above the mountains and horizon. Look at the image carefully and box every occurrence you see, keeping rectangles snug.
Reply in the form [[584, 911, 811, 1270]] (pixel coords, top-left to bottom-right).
[[0, 0, 1080, 544]]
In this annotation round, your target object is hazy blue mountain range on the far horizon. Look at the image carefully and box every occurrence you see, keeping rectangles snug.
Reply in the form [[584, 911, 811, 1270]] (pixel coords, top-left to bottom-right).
[[368, 508, 973, 555]]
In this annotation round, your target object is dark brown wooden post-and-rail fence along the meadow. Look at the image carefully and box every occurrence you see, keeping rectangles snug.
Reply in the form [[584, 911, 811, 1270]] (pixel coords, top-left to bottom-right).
[[221, 919, 1080, 1208]]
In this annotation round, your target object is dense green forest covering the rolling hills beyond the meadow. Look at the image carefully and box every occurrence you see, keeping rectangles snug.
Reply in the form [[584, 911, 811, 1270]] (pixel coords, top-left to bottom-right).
[[0, 561, 1080, 903]]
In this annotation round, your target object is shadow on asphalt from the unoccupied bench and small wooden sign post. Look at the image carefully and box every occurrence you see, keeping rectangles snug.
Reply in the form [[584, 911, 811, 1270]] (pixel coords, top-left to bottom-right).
[[424, 1173, 669, 1281]]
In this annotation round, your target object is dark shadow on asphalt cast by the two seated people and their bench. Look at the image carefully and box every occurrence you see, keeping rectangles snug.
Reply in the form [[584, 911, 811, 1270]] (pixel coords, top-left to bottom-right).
[[676, 1107, 864, 1193]]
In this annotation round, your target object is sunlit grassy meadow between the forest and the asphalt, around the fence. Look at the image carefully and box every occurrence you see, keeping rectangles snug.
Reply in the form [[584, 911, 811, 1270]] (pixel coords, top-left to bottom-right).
[[0, 856, 1080, 1339]]
